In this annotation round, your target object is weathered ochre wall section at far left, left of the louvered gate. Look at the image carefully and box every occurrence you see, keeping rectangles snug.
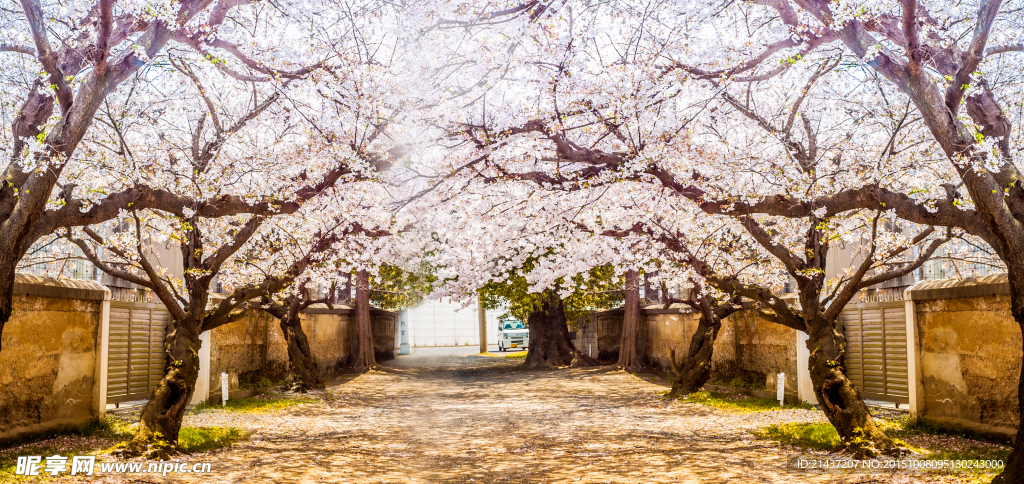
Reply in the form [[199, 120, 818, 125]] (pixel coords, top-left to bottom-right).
[[0, 274, 110, 441]]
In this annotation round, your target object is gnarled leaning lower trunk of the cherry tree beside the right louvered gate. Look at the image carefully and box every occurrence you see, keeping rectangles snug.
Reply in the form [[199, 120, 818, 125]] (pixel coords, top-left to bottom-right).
[[807, 320, 905, 458]]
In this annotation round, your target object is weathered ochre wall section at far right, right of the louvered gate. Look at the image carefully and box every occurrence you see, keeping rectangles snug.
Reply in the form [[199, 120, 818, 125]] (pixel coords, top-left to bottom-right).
[[907, 274, 1022, 435]]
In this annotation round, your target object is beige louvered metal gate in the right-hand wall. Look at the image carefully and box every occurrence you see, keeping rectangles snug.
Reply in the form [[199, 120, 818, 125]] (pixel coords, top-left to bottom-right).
[[840, 301, 910, 405]]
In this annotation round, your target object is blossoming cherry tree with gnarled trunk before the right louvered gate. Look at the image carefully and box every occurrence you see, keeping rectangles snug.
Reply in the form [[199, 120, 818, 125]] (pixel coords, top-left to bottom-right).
[[409, 2, 978, 454]]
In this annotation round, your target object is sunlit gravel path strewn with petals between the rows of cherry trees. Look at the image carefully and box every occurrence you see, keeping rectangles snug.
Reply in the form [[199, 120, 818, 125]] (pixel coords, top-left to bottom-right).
[[88, 349, 958, 483]]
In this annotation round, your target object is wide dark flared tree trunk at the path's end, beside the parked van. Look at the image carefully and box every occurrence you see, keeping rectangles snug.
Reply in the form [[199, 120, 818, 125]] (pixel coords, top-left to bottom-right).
[[523, 290, 597, 367]]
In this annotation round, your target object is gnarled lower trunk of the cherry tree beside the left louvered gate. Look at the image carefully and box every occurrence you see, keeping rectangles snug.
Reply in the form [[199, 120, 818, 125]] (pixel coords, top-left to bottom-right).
[[125, 319, 203, 458]]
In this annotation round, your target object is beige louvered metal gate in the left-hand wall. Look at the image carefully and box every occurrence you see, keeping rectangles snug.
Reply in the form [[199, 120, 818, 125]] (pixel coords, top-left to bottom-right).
[[106, 301, 171, 403]]
